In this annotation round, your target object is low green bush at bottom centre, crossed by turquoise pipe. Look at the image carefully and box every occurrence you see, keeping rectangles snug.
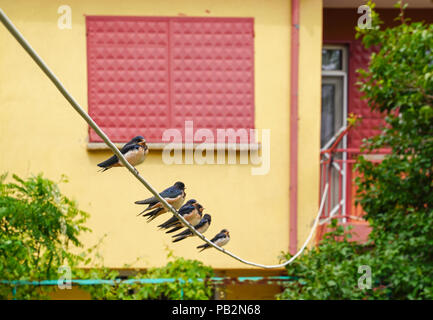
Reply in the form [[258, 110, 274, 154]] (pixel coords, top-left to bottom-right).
[[79, 252, 214, 300]]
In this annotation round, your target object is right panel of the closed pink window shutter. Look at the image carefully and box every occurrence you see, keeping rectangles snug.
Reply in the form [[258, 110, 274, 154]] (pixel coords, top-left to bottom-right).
[[171, 18, 254, 142]]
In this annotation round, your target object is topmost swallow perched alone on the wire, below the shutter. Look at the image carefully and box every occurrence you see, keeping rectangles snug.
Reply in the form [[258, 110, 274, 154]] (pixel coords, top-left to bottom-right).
[[98, 136, 149, 172]]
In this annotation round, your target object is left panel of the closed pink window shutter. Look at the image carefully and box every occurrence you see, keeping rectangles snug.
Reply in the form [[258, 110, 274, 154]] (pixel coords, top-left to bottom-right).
[[86, 17, 170, 142]]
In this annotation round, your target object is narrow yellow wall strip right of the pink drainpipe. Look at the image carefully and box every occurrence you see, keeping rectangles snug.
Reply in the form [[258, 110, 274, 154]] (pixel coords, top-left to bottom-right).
[[298, 0, 322, 247]]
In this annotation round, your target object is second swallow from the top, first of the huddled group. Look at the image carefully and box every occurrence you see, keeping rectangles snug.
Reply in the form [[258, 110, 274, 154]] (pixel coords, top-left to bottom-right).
[[135, 181, 186, 222]]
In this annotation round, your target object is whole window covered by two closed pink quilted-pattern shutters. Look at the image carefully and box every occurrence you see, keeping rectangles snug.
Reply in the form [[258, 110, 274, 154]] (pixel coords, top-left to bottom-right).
[[86, 16, 254, 142]]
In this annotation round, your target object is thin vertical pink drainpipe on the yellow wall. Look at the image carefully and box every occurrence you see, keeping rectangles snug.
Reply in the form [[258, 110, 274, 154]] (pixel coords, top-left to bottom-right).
[[289, 0, 300, 255]]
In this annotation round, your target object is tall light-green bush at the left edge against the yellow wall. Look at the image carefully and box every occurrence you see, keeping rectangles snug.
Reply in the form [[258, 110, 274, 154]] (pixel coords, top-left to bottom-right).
[[0, 174, 89, 299]]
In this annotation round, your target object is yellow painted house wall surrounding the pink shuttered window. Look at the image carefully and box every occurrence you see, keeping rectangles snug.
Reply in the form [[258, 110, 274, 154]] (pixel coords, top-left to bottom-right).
[[0, 0, 322, 268]]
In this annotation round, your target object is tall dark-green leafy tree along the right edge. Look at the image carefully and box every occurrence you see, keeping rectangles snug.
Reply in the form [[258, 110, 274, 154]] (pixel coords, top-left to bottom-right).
[[356, 0, 433, 299]]
